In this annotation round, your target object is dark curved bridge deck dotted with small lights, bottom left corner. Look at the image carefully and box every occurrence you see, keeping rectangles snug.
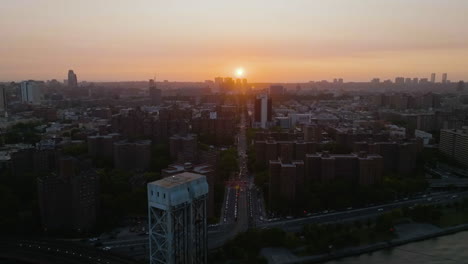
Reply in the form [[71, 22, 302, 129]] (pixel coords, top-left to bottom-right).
[[0, 238, 138, 264]]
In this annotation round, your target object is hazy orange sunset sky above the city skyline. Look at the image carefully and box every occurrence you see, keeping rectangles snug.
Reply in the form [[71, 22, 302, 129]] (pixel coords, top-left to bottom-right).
[[0, 0, 468, 82]]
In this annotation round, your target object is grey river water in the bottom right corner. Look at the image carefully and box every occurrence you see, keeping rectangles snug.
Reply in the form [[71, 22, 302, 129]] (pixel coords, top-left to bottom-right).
[[325, 231, 468, 264]]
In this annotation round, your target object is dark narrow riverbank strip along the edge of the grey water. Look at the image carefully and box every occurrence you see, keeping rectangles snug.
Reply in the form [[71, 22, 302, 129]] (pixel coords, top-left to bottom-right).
[[282, 224, 468, 263]]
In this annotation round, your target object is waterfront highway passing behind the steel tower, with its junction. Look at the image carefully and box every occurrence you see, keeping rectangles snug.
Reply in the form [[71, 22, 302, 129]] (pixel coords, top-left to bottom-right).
[[91, 191, 468, 258]]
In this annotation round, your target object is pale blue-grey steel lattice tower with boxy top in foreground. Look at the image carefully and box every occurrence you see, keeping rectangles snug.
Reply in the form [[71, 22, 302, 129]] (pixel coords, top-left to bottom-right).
[[148, 172, 208, 264]]
